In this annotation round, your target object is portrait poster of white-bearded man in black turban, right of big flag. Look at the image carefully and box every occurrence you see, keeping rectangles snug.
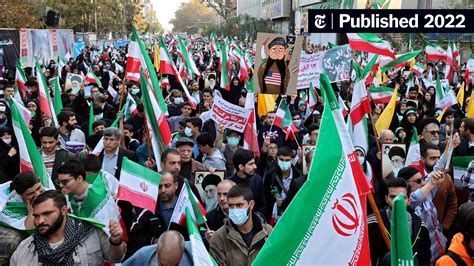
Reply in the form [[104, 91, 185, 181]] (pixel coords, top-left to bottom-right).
[[382, 144, 407, 178]]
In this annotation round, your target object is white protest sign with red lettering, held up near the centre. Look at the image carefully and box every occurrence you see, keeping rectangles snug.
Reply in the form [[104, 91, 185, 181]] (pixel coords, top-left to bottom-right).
[[211, 97, 250, 133]]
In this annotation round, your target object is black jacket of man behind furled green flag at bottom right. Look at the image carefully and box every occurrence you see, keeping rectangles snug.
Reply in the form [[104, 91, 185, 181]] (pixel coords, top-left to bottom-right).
[[367, 208, 431, 266]]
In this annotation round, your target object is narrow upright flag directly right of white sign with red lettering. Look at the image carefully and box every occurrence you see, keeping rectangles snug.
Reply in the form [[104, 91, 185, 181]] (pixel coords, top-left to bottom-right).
[[244, 80, 260, 157]]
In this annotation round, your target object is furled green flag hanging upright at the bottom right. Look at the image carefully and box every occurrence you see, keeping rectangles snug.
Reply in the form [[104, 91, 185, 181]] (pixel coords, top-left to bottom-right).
[[390, 194, 416, 266]]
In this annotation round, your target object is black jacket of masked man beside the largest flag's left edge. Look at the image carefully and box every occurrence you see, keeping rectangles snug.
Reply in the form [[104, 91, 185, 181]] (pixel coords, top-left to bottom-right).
[[263, 166, 305, 221]]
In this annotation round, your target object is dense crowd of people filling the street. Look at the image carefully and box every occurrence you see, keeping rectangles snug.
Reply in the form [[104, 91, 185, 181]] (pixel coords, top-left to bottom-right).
[[0, 33, 474, 265]]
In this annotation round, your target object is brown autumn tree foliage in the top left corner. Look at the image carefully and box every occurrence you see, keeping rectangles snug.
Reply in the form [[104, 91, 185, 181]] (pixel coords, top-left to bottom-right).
[[0, 0, 45, 28]]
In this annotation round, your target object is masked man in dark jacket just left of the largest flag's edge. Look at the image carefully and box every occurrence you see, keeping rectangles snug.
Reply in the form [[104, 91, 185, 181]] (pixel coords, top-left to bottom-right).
[[263, 146, 304, 221]]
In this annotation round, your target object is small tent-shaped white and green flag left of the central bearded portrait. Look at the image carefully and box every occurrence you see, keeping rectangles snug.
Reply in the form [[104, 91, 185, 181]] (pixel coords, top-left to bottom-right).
[[170, 179, 206, 226]]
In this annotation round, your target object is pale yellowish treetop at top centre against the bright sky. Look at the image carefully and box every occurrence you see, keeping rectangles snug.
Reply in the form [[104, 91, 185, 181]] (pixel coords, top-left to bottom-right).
[[171, 0, 216, 33]]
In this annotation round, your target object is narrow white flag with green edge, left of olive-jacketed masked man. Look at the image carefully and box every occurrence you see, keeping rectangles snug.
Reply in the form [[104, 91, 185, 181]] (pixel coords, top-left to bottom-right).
[[185, 207, 217, 266]]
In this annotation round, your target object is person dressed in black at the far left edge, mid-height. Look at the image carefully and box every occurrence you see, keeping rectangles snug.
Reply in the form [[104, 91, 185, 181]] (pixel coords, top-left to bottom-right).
[[0, 126, 20, 184]]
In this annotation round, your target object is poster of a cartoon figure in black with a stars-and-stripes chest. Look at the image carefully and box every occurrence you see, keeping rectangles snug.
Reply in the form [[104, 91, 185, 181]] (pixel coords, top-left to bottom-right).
[[253, 33, 302, 95]]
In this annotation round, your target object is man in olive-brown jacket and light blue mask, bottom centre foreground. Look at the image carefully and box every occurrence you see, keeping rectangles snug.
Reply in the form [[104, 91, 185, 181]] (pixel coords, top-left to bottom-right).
[[209, 185, 272, 266]]
